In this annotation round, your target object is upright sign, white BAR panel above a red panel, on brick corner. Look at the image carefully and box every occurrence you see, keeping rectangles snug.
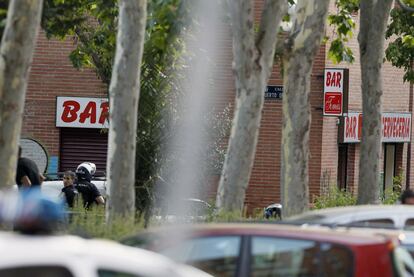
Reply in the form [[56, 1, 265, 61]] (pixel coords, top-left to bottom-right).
[[323, 68, 349, 116]]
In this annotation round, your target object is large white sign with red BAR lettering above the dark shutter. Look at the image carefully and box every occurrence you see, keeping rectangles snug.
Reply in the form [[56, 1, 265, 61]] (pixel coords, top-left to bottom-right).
[[56, 97, 109, 128]]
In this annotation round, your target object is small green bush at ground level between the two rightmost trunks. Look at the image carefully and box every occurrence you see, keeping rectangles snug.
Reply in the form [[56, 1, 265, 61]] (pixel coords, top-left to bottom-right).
[[313, 186, 357, 209]]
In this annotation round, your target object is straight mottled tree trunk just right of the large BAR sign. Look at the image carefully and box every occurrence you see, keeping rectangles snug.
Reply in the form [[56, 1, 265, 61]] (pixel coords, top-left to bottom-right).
[[107, 0, 147, 221]]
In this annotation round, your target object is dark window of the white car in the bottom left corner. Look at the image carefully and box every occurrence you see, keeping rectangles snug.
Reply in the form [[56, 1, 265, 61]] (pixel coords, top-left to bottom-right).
[[0, 265, 73, 277]]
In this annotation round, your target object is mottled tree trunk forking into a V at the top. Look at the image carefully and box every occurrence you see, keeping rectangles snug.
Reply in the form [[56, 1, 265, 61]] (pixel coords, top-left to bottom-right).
[[216, 0, 287, 212]]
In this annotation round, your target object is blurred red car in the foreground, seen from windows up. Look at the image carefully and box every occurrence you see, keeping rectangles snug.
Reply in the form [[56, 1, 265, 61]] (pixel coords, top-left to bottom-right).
[[121, 224, 411, 277]]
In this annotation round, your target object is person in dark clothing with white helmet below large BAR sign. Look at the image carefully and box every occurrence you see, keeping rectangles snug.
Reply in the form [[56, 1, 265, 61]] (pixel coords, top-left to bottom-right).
[[75, 162, 105, 209]]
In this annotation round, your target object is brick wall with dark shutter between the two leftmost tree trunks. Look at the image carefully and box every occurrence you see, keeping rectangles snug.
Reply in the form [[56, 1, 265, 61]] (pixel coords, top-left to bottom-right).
[[21, 32, 107, 176]]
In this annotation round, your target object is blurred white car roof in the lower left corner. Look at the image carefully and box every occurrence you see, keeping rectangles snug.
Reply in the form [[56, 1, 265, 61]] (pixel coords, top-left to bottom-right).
[[0, 232, 183, 276]]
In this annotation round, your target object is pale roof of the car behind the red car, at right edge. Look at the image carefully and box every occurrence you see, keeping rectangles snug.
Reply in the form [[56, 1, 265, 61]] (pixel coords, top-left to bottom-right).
[[285, 205, 414, 221]]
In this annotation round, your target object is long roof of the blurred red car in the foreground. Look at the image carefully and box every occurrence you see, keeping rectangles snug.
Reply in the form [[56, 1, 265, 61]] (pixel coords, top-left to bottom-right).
[[131, 223, 389, 246]]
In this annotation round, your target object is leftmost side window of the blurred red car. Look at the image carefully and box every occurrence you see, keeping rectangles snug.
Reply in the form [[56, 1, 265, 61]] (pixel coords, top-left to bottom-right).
[[160, 236, 241, 277]]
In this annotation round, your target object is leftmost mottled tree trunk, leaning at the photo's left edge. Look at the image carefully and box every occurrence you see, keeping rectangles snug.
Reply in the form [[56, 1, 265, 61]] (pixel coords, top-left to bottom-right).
[[0, 0, 43, 188]]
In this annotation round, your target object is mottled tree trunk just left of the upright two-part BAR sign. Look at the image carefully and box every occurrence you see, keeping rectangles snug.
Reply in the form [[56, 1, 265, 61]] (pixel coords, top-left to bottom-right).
[[281, 0, 329, 216]]
